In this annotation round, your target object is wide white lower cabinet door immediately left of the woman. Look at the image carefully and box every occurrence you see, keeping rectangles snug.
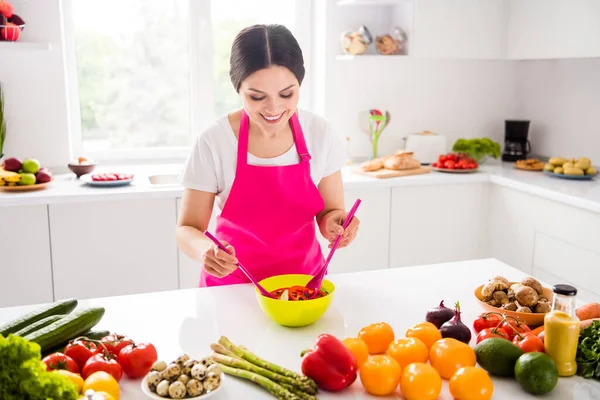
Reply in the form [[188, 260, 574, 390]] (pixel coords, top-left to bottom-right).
[[49, 199, 178, 299]]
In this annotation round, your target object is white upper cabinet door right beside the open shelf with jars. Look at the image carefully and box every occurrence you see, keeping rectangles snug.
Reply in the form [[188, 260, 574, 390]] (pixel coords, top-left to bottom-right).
[[413, 0, 506, 59]]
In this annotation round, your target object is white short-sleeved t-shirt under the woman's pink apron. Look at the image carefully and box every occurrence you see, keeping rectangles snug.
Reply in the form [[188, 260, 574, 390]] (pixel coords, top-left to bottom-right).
[[180, 109, 348, 214]]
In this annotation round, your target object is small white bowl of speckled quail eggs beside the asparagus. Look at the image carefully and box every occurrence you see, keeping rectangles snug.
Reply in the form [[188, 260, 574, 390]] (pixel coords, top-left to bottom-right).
[[142, 354, 224, 399]]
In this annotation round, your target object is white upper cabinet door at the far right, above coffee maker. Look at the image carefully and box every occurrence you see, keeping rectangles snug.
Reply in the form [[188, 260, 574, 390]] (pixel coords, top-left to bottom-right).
[[507, 0, 600, 60]]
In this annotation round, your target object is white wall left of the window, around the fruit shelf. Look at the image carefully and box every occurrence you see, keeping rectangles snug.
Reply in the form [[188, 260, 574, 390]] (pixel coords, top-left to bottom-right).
[[0, 0, 70, 166]]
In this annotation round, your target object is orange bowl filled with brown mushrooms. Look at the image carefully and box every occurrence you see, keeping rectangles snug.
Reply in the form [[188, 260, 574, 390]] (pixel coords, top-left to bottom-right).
[[475, 276, 553, 327]]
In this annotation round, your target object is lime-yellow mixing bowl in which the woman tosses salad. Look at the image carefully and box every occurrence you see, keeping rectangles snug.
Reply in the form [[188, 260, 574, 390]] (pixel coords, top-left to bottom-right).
[[256, 274, 335, 327]]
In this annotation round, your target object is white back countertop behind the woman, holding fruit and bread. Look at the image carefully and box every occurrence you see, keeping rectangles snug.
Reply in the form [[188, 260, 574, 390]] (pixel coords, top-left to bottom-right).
[[0, 160, 600, 213]]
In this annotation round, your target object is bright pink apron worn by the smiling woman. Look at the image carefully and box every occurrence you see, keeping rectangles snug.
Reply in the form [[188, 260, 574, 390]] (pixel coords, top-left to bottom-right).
[[199, 110, 324, 287]]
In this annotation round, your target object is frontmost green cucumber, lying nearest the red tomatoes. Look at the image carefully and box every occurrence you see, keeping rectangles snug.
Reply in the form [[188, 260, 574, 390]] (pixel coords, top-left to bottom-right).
[[25, 307, 104, 352]]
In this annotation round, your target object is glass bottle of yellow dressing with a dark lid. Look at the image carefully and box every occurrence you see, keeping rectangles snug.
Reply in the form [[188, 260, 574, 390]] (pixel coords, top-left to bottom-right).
[[544, 284, 581, 376]]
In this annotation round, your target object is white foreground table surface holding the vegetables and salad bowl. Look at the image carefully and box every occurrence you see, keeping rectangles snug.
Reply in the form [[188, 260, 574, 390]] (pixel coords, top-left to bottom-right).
[[0, 259, 600, 400]]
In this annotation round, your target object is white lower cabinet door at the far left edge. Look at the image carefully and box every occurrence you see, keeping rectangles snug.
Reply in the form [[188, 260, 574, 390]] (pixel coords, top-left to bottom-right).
[[0, 205, 53, 308]]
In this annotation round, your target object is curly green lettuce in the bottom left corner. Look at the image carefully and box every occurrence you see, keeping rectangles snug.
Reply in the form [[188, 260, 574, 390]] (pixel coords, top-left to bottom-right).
[[0, 335, 79, 400]]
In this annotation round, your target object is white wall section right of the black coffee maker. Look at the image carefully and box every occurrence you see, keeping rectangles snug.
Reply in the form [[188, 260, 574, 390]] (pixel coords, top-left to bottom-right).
[[515, 58, 600, 164]]
